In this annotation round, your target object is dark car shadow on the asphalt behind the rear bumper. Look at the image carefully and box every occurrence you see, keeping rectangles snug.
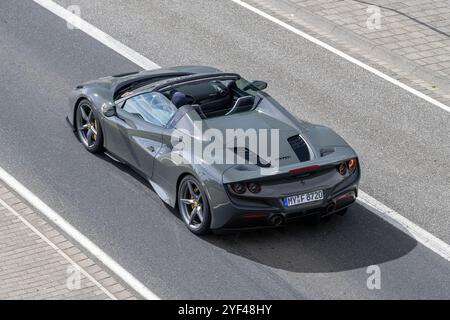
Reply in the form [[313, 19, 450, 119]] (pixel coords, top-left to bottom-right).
[[204, 204, 417, 273]]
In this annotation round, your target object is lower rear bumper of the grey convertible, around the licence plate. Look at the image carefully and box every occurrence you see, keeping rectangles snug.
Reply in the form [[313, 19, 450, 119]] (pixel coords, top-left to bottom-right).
[[211, 167, 360, 230]]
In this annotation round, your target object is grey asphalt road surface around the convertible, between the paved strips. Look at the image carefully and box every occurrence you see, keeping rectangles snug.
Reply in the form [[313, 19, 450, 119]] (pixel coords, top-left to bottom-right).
[[0, 0, 450, 299]]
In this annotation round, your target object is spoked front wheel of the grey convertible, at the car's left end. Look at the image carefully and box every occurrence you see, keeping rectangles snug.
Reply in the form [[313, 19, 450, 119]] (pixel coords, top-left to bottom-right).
[[75, 100, 103, 153]]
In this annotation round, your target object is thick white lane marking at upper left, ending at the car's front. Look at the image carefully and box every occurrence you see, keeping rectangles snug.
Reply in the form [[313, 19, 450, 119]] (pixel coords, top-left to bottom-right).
[[34, 0, 159, 70]]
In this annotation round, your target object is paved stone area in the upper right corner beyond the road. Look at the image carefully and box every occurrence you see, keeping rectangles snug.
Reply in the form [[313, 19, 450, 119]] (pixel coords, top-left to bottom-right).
[[249, 0, 450, 96]]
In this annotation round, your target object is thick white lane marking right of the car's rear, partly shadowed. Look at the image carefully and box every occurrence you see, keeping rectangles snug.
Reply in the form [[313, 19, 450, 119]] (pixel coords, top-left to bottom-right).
[[358, 190, 450, 261]]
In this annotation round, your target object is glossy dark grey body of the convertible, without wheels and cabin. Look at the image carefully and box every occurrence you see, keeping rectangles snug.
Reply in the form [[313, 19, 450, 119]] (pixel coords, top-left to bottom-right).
[[67, 66, 360, 229]]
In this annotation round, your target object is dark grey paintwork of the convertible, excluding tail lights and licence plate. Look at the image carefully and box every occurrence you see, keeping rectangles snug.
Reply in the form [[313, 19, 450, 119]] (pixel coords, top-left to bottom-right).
[[67, 66, 360, 229]]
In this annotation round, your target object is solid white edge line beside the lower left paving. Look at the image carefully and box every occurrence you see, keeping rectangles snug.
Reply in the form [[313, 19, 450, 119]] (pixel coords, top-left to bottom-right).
[[0, 167, 159, 300]]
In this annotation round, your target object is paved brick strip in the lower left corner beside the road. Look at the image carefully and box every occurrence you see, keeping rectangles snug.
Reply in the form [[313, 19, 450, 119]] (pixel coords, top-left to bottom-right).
[[0, 180, 136, 300]]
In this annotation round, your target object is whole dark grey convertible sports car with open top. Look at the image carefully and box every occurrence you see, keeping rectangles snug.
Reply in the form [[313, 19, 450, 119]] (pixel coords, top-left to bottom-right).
[[67, 66, 360, 234]]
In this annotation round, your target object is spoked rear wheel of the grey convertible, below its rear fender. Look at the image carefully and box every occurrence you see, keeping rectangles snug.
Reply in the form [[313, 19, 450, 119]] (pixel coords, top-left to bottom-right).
[[178, 175, 211, 235]]
